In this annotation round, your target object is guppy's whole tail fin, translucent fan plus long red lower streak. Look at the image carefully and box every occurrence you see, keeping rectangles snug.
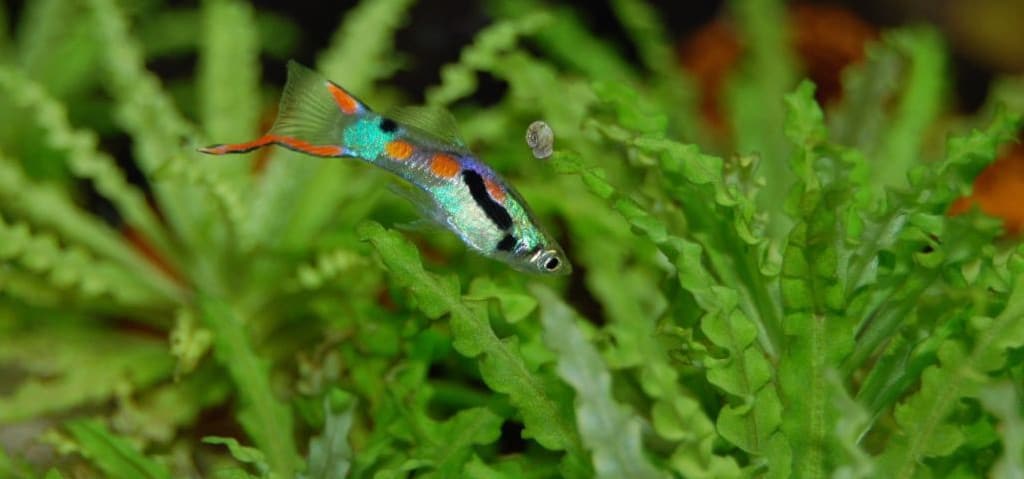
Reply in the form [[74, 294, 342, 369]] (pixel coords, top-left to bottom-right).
[[200, 60, 371, 157]]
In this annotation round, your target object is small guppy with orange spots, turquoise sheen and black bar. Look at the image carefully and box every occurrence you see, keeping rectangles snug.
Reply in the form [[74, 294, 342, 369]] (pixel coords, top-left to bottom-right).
[[200, 61, 571, 274]]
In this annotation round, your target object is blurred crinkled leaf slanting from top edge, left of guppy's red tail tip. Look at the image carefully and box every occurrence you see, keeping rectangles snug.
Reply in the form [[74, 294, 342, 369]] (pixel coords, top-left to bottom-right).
[[87, 0, 248, 278]]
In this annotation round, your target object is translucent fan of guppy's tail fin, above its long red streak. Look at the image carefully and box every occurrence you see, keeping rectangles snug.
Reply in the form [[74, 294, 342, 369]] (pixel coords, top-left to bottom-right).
[[270, 60, 369, 144]]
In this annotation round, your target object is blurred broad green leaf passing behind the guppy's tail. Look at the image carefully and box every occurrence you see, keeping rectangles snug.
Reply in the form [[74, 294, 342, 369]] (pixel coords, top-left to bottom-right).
[[242, 0, 414, 257]]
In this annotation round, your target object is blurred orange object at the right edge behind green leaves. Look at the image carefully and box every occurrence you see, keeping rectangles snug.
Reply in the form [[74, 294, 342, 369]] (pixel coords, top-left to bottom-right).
[[949, 143, 1024, 235]]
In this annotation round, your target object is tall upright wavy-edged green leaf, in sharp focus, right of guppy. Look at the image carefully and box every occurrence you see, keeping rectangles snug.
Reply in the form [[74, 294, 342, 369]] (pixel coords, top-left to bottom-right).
[[777, 82, 855, 477]]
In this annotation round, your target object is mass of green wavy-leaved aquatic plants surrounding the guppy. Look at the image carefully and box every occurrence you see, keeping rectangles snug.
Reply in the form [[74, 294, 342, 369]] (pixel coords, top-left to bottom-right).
[[0, 0, 1024, 479]]
